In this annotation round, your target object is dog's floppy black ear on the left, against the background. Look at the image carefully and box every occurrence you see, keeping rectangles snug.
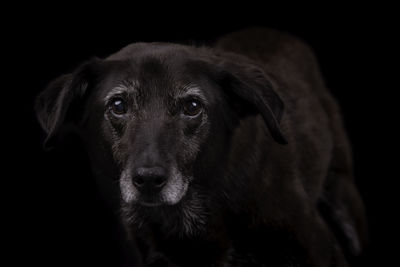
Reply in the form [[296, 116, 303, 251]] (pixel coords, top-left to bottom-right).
[[35, 58, 100, 149]]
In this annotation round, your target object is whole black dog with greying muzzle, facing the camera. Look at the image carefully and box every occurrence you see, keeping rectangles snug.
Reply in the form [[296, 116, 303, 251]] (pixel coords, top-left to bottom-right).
[[36, 29, 366, 267]]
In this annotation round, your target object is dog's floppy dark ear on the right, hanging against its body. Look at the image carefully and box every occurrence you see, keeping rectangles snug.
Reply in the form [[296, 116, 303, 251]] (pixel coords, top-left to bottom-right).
[[212, 53, 287, 144]]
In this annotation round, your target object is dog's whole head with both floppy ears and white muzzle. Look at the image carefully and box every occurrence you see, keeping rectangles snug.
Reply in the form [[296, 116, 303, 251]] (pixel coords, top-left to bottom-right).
[[36, 43, 285, 213]]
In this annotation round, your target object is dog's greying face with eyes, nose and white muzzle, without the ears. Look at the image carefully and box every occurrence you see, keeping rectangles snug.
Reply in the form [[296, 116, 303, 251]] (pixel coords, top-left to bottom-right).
[[88, 52, 229, 207]]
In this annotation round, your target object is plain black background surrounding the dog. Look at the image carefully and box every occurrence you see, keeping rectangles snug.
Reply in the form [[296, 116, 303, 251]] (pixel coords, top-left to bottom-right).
[[2, 5, 398, 266]]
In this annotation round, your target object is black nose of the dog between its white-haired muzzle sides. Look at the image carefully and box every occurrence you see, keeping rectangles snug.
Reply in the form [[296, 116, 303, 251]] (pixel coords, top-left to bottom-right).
[[133, 167, 167, 189]]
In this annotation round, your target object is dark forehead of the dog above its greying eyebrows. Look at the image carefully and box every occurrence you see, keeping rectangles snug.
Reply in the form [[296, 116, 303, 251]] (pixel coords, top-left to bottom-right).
[[101, 43, 211, 98]]
